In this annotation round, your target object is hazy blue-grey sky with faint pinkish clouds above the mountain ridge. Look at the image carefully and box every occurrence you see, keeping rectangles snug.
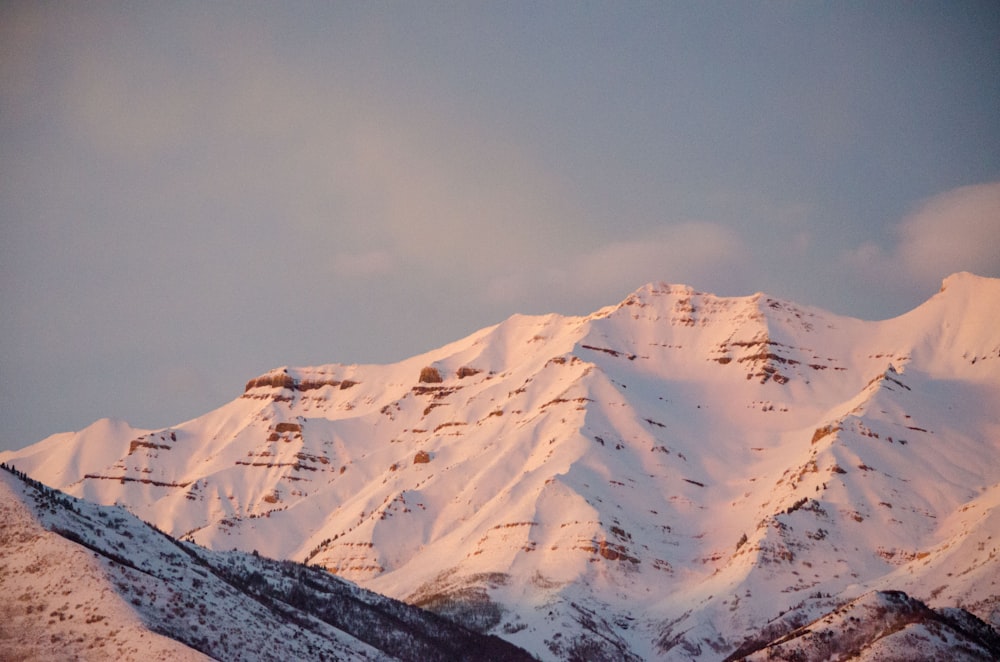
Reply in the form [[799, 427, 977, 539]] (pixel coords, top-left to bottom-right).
[[0, 0, 1000, 450]]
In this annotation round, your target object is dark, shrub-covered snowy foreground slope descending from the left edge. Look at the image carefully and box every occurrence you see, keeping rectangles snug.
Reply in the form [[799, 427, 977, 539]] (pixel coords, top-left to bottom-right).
[[0, 471, 532, 661]]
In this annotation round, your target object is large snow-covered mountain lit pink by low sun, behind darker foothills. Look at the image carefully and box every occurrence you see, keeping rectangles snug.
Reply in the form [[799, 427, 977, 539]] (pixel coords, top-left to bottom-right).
[[7, 274, 1000, 660]]
